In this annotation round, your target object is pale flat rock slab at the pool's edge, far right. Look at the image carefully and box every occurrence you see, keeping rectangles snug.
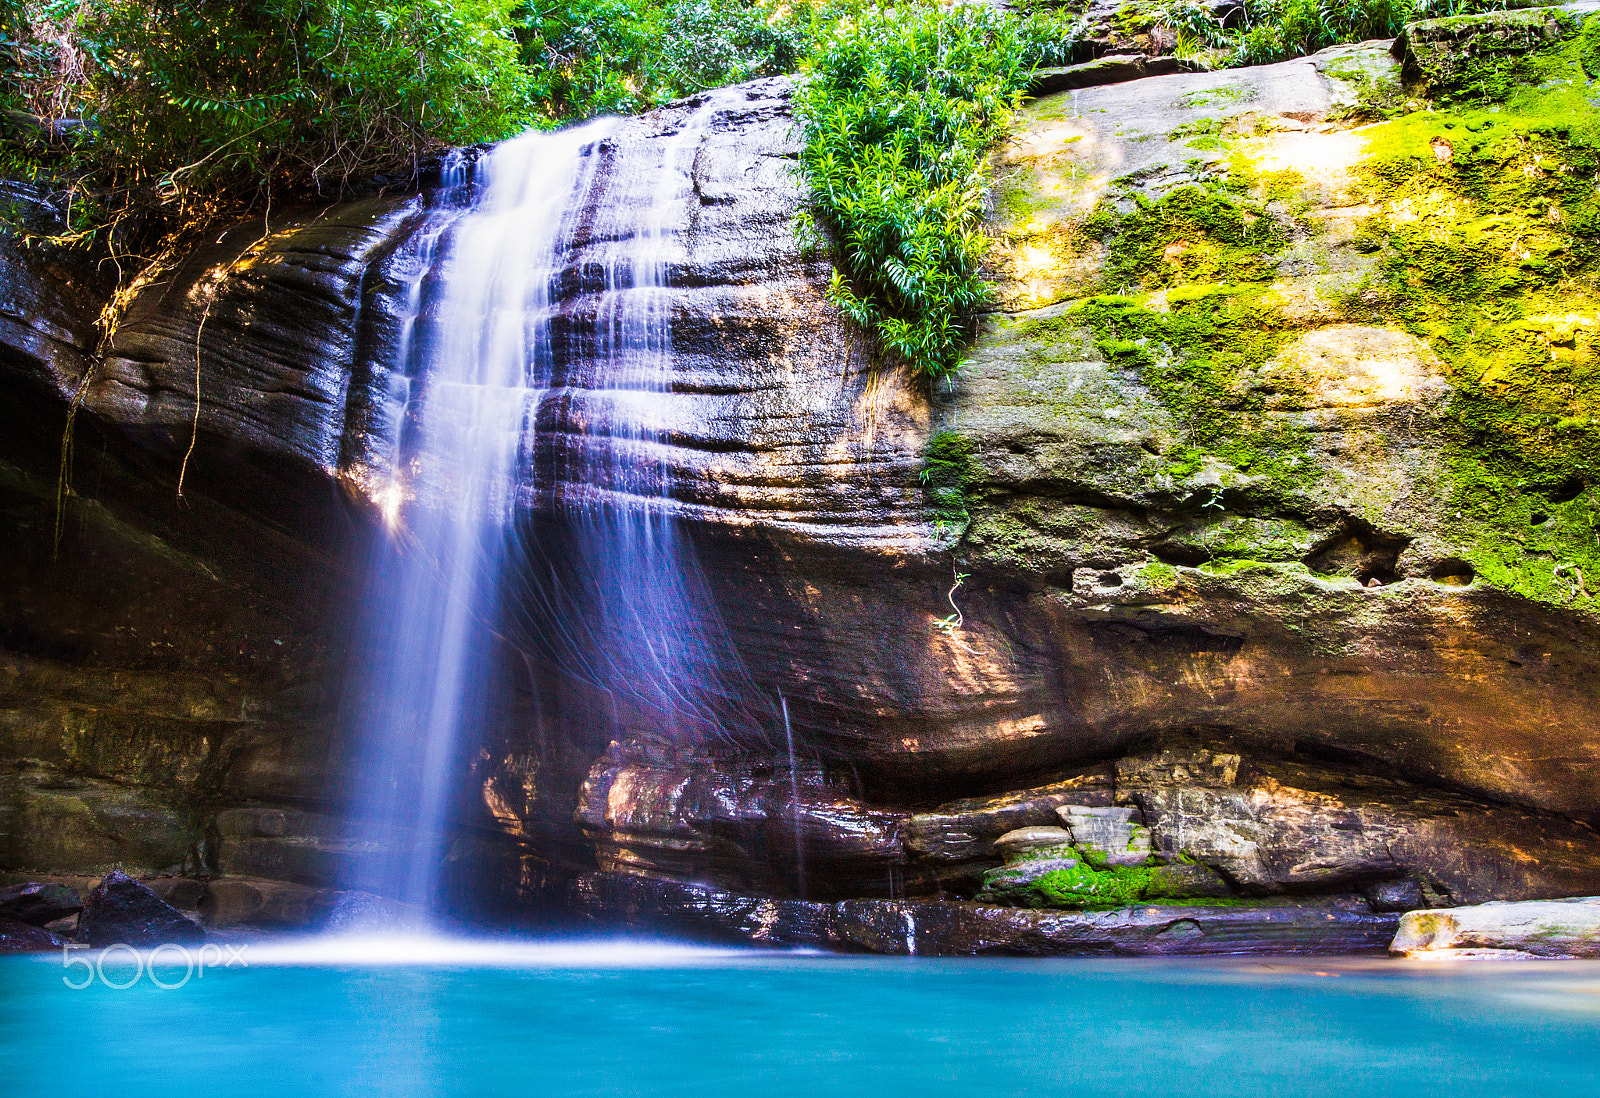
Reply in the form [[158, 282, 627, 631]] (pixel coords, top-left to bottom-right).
[[1389, 896, 1600, 957]]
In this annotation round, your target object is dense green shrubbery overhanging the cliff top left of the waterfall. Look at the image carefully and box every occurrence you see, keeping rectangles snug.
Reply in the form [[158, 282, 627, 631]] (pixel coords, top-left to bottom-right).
[[0, 0, 528, 260]]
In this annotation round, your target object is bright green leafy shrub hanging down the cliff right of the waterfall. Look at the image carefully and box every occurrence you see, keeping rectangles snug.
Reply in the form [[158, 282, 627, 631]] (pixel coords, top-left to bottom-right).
[[797, 6, 1032, 378]]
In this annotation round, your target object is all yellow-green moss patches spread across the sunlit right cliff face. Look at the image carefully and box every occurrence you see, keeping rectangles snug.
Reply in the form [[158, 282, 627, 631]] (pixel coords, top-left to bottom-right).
[[984, 25, 1600, 611]]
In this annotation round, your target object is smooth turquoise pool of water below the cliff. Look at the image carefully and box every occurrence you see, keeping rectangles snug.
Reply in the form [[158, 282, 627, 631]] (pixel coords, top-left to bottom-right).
[[0, 941, 1600, 1098]]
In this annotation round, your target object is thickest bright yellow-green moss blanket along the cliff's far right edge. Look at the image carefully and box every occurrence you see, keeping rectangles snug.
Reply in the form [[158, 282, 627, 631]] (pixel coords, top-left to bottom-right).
[[1358, 28, 1600, 610]]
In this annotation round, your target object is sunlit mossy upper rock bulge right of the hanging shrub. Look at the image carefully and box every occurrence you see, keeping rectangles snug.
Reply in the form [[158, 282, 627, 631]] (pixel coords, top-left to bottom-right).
[[936, 10, 1600, 819]]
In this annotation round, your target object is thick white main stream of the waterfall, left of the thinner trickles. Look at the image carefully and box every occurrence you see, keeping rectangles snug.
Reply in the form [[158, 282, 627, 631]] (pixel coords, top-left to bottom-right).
[[352, 123, 606, 908]]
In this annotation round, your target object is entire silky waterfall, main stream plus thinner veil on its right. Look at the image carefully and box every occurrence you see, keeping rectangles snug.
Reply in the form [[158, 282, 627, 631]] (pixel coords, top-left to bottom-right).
[[347, 98, 764, 908]]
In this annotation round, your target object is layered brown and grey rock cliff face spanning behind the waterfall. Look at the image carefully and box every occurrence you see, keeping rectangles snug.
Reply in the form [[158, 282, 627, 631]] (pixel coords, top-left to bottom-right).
[[0, 25, 1600, 952]]
